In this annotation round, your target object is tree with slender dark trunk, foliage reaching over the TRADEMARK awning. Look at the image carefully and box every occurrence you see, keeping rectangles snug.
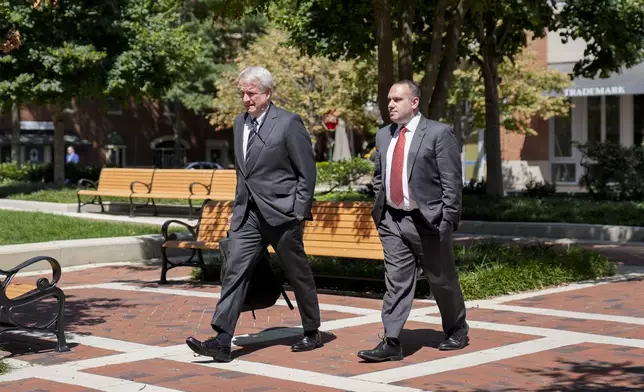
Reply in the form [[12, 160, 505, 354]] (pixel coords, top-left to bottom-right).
[[462, 0, 644, 197]]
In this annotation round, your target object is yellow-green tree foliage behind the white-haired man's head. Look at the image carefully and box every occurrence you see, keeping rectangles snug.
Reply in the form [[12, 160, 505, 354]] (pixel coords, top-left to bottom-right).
[[210, 28, 375, 133]]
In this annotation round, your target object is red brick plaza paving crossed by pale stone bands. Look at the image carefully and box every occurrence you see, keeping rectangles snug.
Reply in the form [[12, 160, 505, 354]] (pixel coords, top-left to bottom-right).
[[0, 258, 644, 392]]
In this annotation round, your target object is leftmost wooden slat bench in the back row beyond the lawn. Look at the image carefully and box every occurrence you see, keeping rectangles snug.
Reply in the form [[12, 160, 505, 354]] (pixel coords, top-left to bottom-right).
[[76, 167, 154, 212]]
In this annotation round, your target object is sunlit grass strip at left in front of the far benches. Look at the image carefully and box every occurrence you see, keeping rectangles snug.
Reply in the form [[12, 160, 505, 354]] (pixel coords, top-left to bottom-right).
[[0, 210, 161, 245]]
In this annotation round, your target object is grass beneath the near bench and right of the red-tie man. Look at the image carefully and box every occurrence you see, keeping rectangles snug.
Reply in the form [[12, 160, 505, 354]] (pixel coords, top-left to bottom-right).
[[193, 241, 617, 300]]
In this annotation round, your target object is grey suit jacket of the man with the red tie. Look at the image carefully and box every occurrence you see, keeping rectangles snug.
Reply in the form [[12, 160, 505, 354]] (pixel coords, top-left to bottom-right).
[[371, 115, 463, 230]]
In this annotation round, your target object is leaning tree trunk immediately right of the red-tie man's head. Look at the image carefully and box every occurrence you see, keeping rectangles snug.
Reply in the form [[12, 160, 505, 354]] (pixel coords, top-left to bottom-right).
[[418, 0, 447, 116]]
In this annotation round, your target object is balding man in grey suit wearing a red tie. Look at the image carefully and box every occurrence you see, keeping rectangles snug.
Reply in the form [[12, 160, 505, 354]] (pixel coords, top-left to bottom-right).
[[358, 80, 469, 362]]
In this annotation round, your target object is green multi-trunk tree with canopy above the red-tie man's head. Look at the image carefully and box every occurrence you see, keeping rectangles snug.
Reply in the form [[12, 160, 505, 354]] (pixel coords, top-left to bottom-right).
[[204, 0, 470, 123]]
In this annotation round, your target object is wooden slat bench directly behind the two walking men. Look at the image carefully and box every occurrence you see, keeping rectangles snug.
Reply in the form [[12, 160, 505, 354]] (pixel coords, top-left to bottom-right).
[[160, 201, 383, 283]]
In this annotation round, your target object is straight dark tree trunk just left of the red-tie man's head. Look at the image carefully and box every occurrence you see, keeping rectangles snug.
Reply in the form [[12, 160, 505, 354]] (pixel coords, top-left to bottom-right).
[[372, 0, 394, 124]]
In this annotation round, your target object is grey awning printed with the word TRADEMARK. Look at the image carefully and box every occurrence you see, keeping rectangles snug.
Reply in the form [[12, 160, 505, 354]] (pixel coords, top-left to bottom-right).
[[548, 63, 644, 97]]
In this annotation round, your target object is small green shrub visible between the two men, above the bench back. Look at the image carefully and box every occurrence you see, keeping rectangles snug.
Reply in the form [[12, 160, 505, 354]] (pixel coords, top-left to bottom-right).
[[317, 157, 373, 192]]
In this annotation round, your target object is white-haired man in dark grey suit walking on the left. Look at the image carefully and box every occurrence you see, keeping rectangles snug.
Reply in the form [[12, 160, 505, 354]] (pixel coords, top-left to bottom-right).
[[186, 67, 322, 362]]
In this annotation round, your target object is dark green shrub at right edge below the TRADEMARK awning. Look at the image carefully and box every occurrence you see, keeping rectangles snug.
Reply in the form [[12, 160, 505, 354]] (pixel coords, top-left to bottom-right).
[[576, 142, 644, 200]]
